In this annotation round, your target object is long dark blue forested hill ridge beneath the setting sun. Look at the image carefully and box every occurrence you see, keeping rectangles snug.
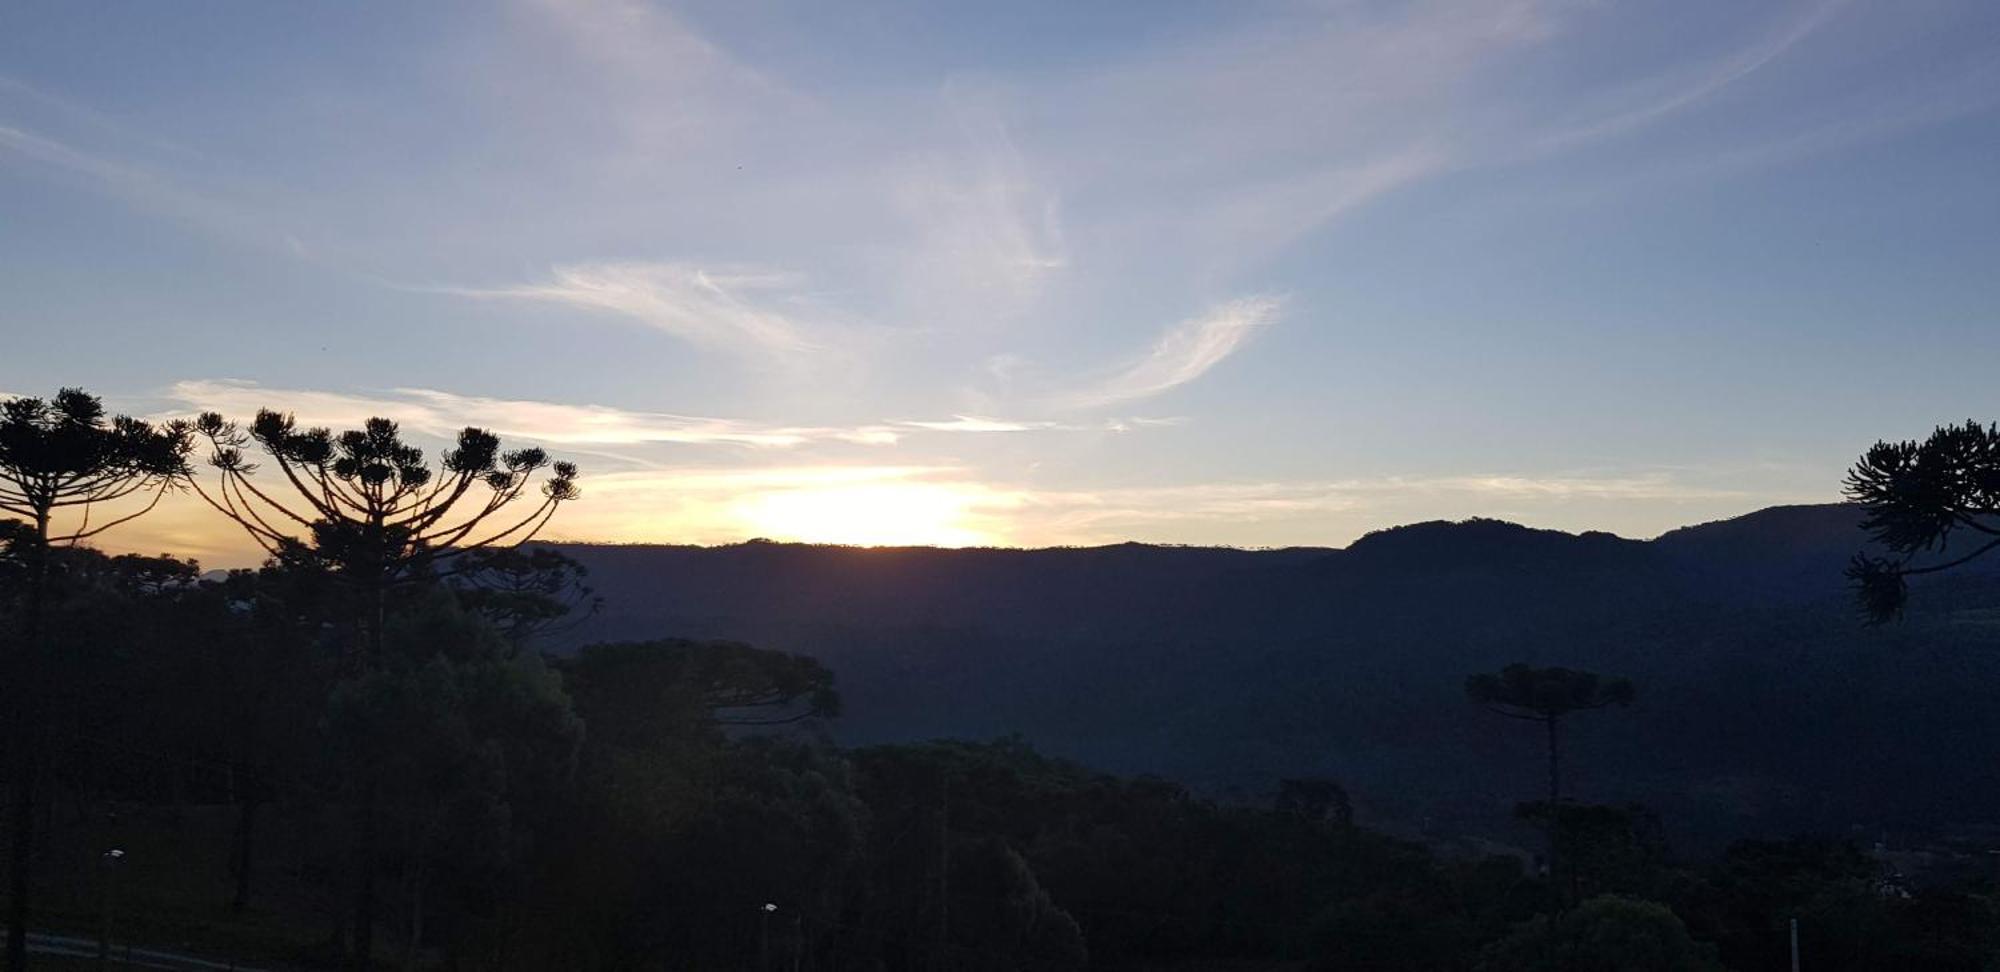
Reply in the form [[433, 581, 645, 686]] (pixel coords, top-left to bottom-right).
[[544, 506, 2000, 842]]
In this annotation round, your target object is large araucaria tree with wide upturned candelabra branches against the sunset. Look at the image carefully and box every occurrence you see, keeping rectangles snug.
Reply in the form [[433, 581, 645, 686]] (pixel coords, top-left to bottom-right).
[[194, 410, 578, 968]]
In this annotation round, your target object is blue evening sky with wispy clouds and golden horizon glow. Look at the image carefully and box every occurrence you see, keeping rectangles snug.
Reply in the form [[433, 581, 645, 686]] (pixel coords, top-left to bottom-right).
[[0, 0, 2000, 566]]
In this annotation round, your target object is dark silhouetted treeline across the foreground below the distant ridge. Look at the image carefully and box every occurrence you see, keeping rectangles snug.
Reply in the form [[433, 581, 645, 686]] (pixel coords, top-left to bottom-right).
[[0, 392, 2000, 972]]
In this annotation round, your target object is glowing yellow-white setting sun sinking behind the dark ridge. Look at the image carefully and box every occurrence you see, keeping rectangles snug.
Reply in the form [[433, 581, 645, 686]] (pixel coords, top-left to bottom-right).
[[736, 482, 998, 546]]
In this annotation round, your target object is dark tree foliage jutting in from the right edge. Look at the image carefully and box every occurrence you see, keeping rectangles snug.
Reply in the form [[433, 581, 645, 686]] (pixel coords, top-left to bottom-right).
[[1846, 422, 2000, 624]]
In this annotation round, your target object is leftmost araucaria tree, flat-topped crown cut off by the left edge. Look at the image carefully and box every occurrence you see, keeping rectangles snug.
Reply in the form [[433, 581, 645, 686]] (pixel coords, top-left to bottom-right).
[[0, 388, 190, 970]]
